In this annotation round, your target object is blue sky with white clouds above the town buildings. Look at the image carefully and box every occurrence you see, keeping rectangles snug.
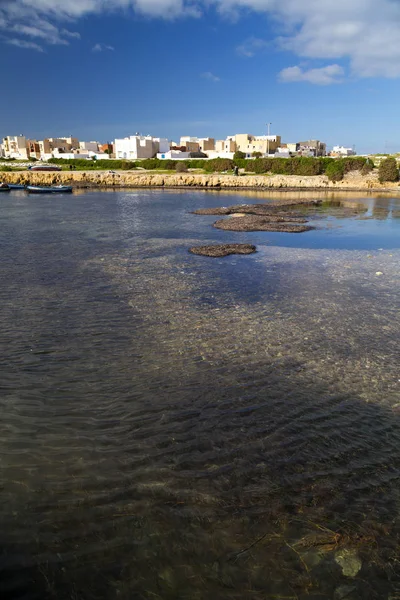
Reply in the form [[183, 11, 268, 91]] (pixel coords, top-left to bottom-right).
[[0, 0, 400, 153]]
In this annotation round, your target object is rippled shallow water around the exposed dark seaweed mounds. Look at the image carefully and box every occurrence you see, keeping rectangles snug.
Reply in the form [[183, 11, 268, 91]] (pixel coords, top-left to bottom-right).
[[0, 191, 400, 600]]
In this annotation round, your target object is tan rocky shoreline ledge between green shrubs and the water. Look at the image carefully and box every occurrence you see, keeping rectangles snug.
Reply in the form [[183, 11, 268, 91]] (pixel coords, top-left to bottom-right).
[[0, 171, 400, 192]]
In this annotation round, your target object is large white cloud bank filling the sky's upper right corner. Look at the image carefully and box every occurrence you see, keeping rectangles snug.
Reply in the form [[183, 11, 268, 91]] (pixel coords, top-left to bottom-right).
[[216, 0, 400, 77]]
